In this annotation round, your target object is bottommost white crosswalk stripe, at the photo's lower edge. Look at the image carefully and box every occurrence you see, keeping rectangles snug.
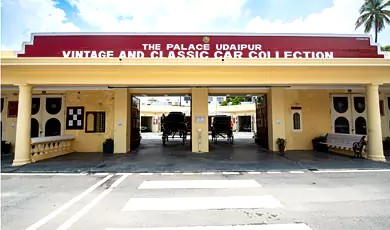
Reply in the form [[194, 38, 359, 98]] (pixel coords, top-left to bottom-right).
[[106, 224, 312, 230]]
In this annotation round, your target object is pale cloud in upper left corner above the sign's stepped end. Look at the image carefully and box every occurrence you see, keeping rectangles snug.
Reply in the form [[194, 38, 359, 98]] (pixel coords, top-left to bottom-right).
[[1, 0, 80, 50]]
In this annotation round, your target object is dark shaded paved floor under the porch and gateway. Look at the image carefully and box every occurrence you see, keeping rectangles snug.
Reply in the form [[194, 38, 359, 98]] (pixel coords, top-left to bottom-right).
[[1, 138, 390, 173]]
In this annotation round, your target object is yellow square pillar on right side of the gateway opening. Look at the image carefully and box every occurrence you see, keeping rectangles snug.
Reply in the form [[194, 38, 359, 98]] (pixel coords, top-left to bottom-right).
[[267, 88, 288, 151]]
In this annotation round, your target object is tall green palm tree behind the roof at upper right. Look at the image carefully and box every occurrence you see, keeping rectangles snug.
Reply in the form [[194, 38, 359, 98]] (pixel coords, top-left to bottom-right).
[[355, 0, 390, 43]]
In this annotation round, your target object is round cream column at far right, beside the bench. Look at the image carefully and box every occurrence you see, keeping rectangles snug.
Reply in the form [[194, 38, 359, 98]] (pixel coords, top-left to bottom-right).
[[366, 84, 386, 161]]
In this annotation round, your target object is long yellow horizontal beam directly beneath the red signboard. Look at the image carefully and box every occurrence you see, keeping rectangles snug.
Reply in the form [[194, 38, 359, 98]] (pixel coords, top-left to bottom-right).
[[1, 58, 390, 86]]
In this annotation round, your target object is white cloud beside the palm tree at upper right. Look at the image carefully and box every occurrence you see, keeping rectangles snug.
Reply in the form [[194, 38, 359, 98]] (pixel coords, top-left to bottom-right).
[[245, 0, 390, 43]]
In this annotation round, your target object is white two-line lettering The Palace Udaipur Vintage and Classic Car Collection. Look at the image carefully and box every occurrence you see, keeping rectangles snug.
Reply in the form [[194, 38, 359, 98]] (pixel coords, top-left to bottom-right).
[[62, 44, 334, 59]]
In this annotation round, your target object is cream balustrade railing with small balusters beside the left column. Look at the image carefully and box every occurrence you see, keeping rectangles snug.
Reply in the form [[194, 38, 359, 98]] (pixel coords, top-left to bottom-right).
[[30, 135, 75, 162]]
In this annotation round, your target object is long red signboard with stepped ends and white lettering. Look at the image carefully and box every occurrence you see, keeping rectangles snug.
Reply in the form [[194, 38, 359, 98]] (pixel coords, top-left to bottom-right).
[[18, 33, 384, 58]]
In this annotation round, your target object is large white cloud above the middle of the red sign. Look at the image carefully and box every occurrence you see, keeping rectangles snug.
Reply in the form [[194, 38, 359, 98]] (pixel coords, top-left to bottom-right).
[[68, 0, 247, 32]]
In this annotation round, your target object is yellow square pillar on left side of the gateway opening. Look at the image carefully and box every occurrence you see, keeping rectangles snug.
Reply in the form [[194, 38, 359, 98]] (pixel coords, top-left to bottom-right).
[[114, 89, 130, 153]]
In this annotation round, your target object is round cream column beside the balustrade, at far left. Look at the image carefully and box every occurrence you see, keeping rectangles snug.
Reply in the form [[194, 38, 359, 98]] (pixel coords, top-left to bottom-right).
[[12, 85, 32, 166]]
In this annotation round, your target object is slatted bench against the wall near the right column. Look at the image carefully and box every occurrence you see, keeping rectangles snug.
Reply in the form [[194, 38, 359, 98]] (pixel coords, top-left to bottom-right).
[[321, 133, 367, 158]]
